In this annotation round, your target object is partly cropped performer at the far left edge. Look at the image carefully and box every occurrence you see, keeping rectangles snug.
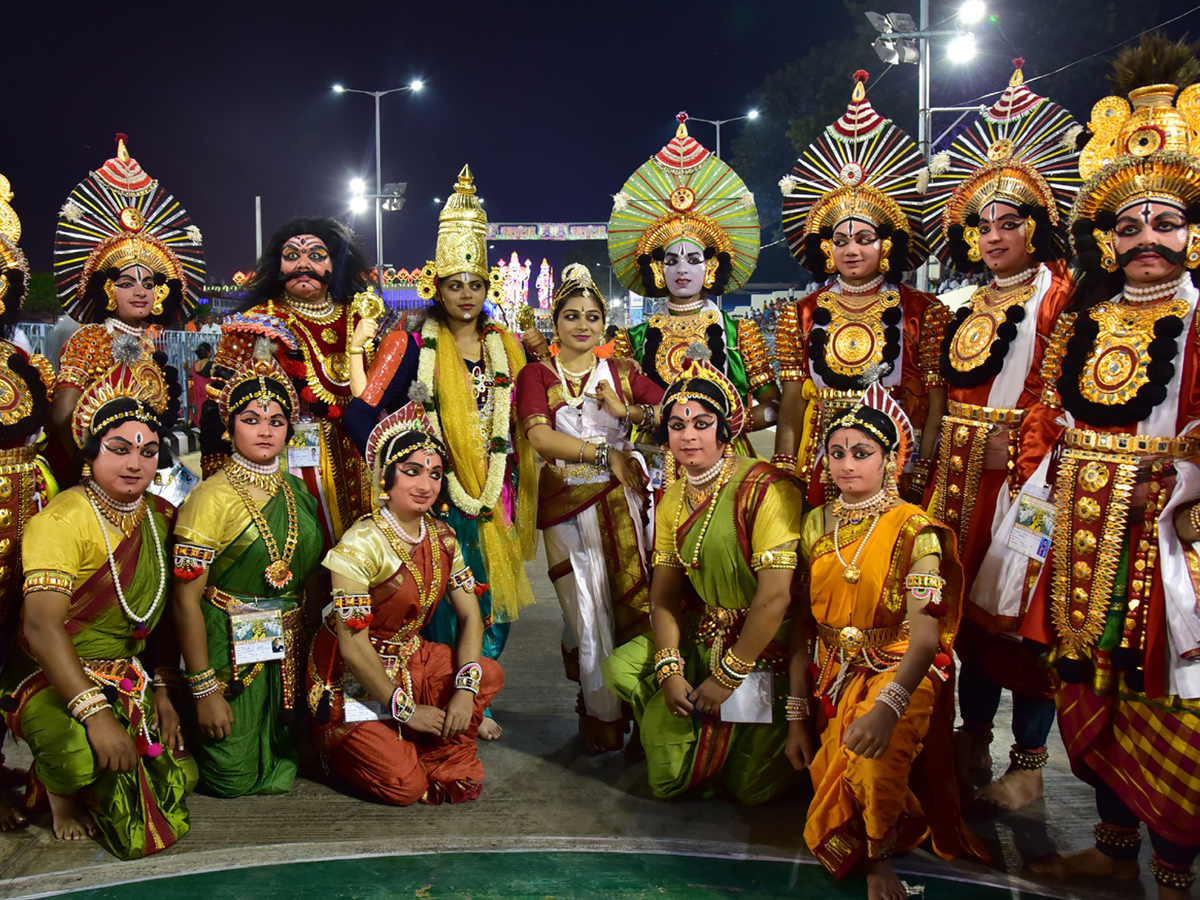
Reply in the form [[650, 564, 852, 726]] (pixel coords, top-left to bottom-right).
[[0, 175, 54, 832]]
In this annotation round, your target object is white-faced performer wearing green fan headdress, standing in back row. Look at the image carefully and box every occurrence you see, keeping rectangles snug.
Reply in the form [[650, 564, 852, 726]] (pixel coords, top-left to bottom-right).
[[608, 113, 779, 465]]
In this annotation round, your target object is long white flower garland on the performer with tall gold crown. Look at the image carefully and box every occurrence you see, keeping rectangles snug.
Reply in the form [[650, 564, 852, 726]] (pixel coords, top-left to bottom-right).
[[416, 318, 512, 521]]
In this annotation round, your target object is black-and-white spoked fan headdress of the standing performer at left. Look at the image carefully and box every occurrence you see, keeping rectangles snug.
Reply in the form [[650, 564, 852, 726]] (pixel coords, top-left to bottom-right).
[[54, 134, 204, 322]]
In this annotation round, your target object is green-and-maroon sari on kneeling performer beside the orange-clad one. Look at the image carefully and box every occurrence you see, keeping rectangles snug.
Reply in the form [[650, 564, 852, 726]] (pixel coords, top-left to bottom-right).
[[604, 457, 800, 804]]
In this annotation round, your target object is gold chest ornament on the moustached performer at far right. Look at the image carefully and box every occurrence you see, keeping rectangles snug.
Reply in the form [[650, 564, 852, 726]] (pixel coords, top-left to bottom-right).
[[1079, 300, 1188, 406]]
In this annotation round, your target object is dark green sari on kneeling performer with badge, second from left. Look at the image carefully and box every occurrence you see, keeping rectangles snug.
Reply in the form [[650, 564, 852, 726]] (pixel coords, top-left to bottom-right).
[[187, 474, 323, 797]]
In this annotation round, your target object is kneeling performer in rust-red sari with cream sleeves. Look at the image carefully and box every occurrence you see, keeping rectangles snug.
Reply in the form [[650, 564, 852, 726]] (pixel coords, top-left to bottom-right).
[[308, 398, 504, 805]]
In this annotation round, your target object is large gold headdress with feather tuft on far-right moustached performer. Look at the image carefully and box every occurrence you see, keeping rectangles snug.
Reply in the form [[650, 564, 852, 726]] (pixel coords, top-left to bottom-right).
[[1070, 36, 1200, 271]]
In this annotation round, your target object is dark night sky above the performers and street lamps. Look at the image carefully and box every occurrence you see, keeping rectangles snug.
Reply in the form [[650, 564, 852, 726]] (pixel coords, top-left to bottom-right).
[[0, 0, 1195, 289]]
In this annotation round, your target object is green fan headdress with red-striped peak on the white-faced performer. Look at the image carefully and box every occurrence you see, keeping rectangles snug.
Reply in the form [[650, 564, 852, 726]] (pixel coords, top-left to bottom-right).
[[608, 113, 760, 296]]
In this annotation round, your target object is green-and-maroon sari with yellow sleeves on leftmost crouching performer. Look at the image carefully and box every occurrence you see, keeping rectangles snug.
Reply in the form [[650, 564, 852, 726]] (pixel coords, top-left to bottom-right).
[[0, 492, 196, 859]]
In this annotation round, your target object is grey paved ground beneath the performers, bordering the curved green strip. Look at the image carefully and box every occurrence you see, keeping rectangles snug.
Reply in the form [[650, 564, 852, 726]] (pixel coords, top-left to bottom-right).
[[0, 444, 1154, 900]]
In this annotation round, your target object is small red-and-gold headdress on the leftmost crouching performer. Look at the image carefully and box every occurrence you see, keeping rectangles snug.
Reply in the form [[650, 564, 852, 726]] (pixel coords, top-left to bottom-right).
[[71, 335, 170, 450]]
